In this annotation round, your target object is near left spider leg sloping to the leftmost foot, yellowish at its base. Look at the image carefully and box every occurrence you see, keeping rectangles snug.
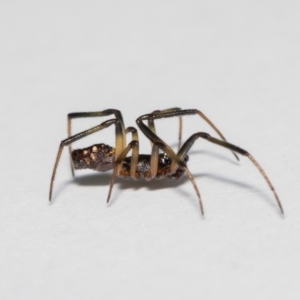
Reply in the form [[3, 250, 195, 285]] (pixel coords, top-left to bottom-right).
[[49, 119, 125, 201]]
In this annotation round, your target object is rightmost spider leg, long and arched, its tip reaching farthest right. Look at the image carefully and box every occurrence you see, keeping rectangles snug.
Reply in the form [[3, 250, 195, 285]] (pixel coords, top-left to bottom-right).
[[177, 132, 283, 214]]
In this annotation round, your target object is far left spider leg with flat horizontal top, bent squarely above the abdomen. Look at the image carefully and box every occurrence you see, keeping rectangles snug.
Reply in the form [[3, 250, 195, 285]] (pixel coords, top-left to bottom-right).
[[68, 109, 126, 177]]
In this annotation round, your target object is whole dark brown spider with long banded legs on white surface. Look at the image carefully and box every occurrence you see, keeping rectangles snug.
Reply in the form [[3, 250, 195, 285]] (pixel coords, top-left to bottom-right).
[[49, 107, 283, 215]]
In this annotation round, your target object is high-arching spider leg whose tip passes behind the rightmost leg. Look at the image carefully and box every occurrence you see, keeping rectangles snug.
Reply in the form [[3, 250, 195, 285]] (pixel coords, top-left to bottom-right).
[[136, 108, 239, 163]]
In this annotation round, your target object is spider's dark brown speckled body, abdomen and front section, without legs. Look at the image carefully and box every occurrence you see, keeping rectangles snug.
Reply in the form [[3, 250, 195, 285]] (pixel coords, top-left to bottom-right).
[[71, 144, 188, 180]]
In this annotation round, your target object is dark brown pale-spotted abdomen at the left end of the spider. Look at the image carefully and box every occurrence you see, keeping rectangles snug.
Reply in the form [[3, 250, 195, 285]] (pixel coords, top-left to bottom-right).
[[72, 144, 115, 172]]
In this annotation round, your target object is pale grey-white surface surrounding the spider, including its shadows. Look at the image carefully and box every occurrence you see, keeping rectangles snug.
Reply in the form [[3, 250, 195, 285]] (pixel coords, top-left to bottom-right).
[[0, 0, 300, 300]]
